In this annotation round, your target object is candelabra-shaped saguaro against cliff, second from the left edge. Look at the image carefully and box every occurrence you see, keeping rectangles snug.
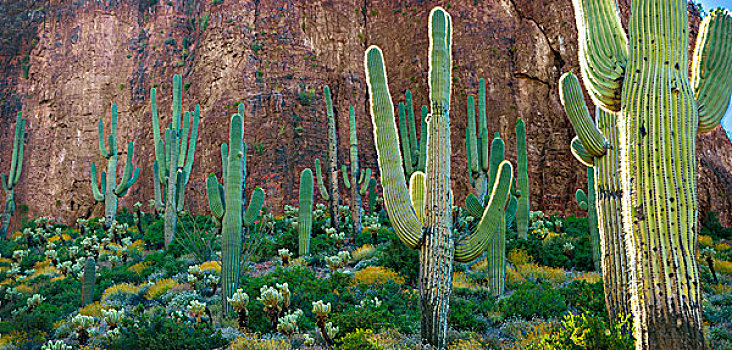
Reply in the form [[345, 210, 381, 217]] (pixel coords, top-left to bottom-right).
[[91, 103, 140, 228]]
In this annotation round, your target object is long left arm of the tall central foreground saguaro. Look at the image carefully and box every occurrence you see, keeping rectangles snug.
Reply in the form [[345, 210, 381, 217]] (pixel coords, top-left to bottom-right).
[[364, 46, 422, 248]]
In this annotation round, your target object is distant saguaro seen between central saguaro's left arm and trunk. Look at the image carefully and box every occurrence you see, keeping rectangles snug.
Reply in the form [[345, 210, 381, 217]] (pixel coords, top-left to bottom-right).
[[398, 90, 428, 176]]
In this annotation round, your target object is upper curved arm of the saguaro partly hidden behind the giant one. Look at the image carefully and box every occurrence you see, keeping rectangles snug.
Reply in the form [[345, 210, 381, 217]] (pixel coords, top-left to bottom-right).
[[559, 73, 610, 157]]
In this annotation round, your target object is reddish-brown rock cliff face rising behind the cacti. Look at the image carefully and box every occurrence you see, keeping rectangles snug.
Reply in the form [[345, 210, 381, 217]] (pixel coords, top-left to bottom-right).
[[0, 0, 732, 225]]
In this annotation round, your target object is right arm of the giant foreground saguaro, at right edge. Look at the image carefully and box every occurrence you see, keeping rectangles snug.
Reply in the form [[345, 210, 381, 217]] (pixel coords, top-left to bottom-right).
[[691, 9, 732, 133]]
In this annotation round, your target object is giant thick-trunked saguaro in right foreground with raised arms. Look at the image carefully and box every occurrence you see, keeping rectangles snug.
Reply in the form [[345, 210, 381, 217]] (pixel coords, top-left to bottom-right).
[[573, 0, 732, 349]]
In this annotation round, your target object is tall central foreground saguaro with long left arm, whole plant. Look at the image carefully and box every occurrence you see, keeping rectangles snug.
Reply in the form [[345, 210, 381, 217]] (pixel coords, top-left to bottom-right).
[[364, 7, 513, 348]]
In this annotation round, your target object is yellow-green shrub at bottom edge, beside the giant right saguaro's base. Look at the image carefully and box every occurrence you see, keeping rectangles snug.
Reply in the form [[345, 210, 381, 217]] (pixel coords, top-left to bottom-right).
[[536, 313, 634, 350]]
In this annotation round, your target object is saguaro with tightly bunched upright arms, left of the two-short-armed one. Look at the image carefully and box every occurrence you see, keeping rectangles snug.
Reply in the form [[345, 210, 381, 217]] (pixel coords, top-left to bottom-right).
[[150, 75, 201, 248]]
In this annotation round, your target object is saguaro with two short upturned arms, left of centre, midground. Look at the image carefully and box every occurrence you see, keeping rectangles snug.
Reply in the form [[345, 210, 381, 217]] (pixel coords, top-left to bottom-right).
[[206, 112, 264, 315]]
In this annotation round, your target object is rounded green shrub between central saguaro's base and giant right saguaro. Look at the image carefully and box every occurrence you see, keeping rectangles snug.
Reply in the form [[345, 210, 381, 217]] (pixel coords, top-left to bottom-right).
[[499, 282, 567, 319]]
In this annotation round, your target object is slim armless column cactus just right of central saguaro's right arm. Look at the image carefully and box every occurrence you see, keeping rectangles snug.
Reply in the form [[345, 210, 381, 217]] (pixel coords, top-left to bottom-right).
[[516, 118, 530, 238]]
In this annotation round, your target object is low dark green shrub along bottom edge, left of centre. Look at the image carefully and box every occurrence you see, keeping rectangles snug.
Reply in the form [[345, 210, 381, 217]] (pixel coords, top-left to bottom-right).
[[104, 310, 227, 350]]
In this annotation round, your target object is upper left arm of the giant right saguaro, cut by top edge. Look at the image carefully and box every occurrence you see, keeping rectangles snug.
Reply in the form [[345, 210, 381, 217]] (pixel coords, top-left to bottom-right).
[[572, 0, 628, 112]]
